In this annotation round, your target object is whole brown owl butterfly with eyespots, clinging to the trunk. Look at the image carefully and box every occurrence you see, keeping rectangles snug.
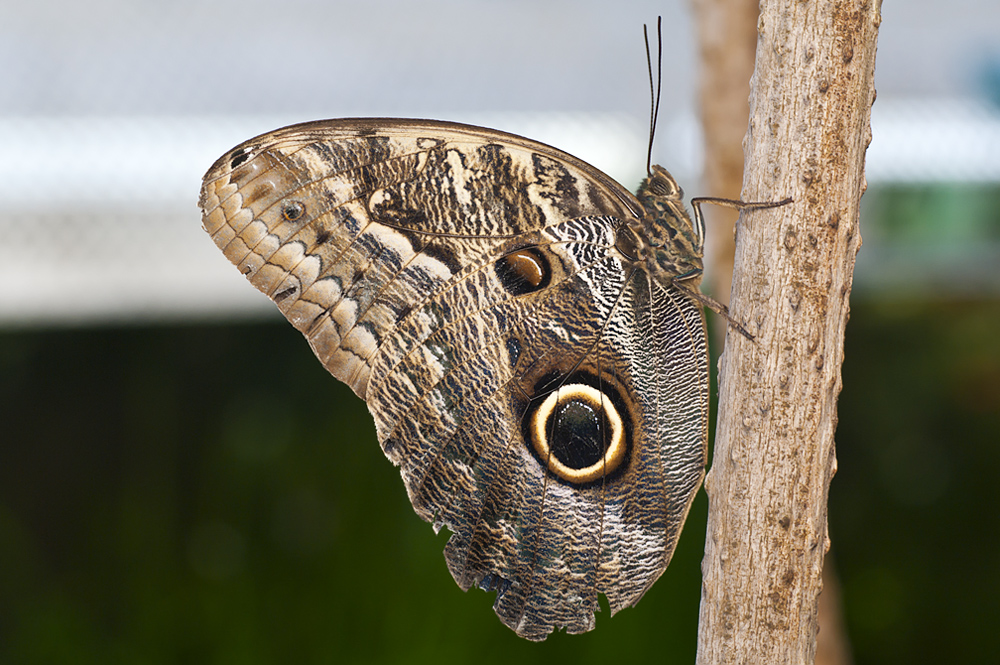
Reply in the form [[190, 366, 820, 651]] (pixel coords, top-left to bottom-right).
[[200, 118, 788, 640]]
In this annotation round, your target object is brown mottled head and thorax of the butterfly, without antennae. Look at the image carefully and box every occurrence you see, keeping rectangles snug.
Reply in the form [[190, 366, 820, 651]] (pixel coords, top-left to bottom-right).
[[633, 165, 705, 281]]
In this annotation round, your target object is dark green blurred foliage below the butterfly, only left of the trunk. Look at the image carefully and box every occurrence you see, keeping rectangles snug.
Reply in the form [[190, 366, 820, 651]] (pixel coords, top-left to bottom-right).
[[0, 322, 705, 663]]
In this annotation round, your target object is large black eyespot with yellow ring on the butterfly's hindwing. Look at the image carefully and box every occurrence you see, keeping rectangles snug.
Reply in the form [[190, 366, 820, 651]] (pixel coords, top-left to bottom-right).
[[525, 383, 631, 485]]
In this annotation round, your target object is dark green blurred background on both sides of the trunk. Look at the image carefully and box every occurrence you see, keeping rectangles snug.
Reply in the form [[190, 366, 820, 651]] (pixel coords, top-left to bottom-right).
[[0, 282, 1000, 663]]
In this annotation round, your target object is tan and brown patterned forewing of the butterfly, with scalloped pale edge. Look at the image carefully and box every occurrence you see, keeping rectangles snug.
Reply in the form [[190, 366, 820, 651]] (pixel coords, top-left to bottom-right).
[[200, 119, 638, 397]]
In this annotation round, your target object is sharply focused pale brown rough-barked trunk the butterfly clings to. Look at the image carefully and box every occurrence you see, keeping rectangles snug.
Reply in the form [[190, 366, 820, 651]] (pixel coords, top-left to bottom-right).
[[698, 0, 880, 664]]
